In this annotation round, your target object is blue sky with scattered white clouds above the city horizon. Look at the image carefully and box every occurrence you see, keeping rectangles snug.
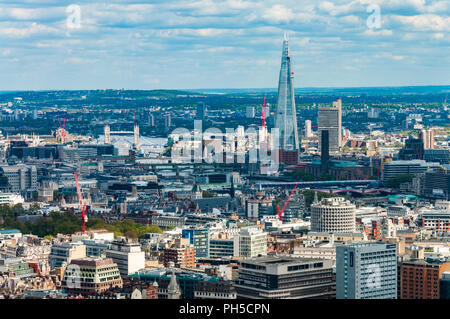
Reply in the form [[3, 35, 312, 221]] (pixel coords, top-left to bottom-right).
[[0, 0, 450, 91]]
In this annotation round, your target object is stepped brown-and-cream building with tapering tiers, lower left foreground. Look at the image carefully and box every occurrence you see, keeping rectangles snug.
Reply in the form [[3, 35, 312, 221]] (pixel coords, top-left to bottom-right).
[[62, 257, 123, 296]]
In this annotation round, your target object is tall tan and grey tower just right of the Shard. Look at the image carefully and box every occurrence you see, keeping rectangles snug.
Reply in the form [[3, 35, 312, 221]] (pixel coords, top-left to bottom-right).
[[318, 99, 342, 152]]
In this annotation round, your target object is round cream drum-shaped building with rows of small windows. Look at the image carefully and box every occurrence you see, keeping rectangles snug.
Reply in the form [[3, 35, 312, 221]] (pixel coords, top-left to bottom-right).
[[311, 197, 356, 233]]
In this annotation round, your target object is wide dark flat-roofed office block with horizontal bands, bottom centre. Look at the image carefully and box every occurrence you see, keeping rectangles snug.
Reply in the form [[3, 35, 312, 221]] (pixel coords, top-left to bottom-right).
[[235, 257, 336, 299]]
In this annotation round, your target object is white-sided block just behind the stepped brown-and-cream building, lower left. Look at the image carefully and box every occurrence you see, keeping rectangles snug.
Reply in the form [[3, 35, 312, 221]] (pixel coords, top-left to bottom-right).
[[105, 237, 145, 278]]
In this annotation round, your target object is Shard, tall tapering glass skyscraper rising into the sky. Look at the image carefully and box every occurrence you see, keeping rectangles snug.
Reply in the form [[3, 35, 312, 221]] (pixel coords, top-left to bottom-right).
[[275, 34, 299, 151]]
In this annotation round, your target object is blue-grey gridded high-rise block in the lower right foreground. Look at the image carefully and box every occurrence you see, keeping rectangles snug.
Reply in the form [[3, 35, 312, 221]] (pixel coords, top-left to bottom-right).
[[336, 242, 397, 299]]
